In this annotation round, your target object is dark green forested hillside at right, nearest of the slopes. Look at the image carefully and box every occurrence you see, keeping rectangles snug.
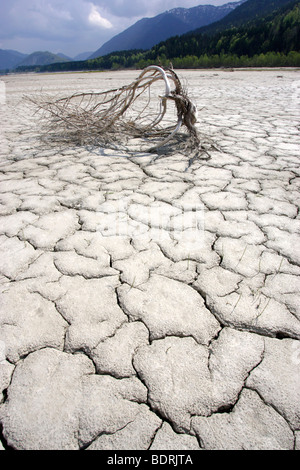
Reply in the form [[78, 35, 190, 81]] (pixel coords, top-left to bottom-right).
[[145, 2, 300, 67]]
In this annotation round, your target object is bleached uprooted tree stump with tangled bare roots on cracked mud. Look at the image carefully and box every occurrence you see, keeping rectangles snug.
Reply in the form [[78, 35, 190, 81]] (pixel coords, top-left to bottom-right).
[[27, 65, 216, 165]]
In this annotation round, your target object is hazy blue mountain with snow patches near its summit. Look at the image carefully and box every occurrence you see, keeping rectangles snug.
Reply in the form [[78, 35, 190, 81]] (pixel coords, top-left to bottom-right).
[[89, 0, 246, 59]]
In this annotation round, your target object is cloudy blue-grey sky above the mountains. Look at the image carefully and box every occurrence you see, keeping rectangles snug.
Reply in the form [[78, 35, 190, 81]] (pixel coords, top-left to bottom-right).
[[0, 0, 230, 57]]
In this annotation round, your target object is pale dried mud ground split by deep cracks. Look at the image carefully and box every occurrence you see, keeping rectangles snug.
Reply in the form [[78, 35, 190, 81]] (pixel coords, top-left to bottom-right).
[[0, 70, 300, 450]]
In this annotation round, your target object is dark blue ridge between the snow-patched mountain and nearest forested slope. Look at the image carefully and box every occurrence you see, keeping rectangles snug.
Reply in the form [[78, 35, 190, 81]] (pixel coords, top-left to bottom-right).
[[188, 0, 291, 35]]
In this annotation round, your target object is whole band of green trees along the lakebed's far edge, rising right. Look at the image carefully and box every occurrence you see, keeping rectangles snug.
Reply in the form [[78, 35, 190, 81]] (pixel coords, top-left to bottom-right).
[[17, 1, 300, 72]]
